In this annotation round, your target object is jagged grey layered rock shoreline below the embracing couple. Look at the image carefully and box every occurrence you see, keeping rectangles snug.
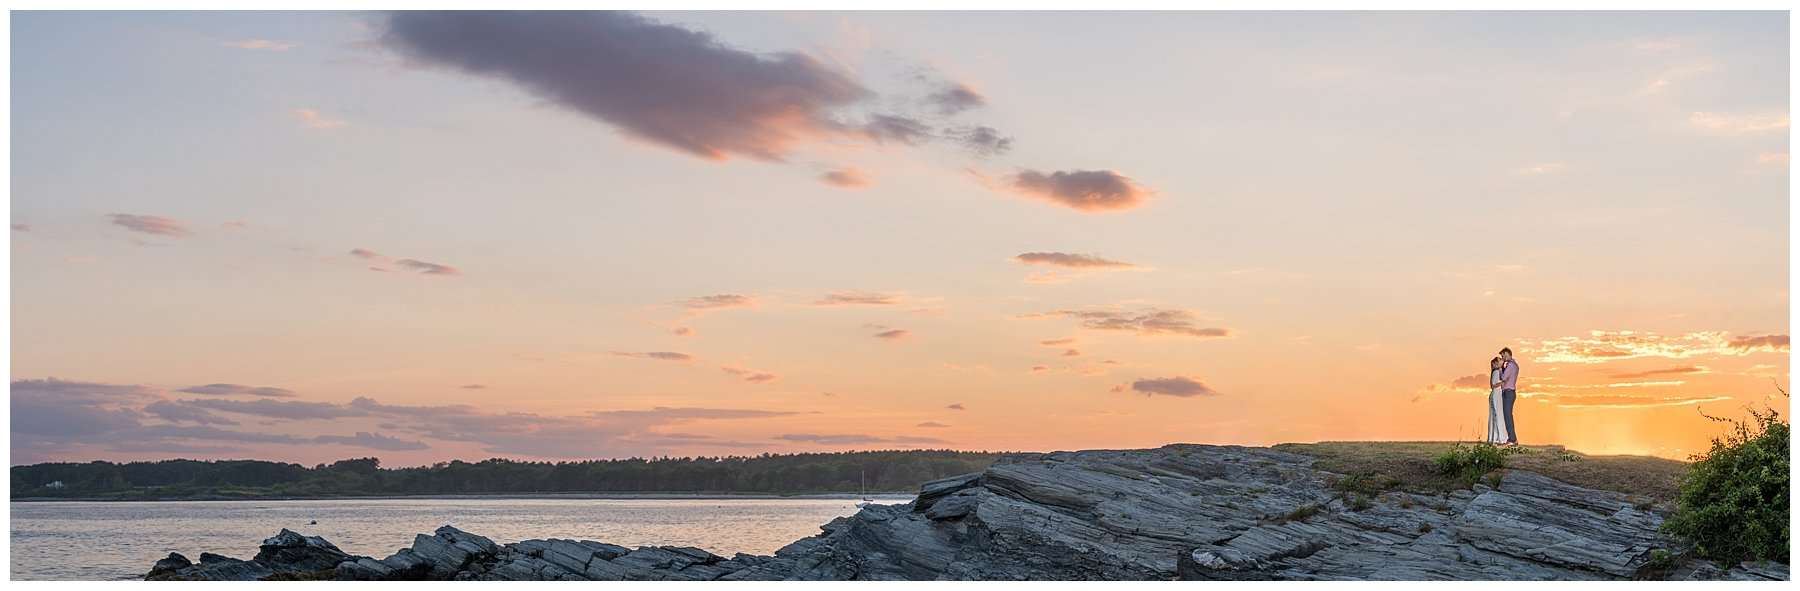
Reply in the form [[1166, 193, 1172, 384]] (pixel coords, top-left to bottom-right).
[[144, 445, 1789, 580]]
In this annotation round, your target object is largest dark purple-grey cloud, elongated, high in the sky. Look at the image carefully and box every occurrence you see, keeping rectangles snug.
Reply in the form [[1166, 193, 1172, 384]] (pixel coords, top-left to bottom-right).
[[382, 11, 871, 160]]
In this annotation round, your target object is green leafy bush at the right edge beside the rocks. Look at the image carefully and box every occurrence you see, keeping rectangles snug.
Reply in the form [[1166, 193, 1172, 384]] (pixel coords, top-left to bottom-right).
[[1663, 391, 1789, 564]]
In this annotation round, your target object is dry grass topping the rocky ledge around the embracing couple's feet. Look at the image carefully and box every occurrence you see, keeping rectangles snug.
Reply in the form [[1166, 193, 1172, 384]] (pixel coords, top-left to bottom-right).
[[1274, 441, 1687, 503]]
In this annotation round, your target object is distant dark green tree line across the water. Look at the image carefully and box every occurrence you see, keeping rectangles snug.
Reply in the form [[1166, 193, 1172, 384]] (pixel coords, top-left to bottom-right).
[[13, 450, 1001, 499]]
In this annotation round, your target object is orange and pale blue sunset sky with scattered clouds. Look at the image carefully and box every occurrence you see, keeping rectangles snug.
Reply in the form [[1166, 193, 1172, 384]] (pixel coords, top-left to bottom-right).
[[11, 13, 1789, 465]]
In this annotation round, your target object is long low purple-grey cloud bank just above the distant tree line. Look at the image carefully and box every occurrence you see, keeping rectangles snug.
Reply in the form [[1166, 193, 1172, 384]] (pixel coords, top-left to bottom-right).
[[11, 376, 810, 463]]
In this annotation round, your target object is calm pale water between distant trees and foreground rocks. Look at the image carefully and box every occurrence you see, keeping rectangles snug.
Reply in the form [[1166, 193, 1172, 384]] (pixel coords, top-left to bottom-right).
[[0, 497, 909, 580]]
